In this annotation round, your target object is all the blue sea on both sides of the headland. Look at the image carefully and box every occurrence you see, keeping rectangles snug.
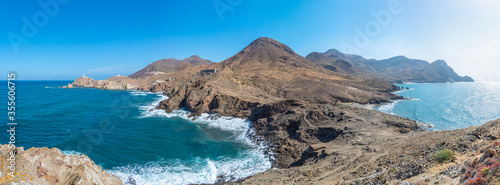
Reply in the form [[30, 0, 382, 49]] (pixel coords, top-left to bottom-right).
[[4, 81, 500, 184]]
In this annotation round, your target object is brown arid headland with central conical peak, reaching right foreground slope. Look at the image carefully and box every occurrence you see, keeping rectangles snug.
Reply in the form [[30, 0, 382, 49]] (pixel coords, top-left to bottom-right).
[[9, 38, 500, 184]]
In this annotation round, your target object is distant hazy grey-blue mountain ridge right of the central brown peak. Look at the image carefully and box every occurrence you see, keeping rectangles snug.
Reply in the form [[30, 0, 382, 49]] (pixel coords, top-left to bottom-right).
[[307, 49, 474, 83]]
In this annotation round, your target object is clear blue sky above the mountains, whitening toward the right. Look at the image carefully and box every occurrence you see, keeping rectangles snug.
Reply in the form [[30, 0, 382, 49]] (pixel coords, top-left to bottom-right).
[[0, 0, 500, 80]]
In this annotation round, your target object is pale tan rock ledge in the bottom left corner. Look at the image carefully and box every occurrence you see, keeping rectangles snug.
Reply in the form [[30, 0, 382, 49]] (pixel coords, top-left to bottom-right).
[[0, 145, 123, 185]]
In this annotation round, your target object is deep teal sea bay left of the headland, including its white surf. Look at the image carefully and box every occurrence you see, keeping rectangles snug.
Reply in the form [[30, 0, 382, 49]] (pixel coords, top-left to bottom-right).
[[0, 81, 271, 184]]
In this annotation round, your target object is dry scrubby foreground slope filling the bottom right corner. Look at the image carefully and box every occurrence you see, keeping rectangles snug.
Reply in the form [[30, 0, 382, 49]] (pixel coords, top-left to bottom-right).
[[234, 119, 500, 185]]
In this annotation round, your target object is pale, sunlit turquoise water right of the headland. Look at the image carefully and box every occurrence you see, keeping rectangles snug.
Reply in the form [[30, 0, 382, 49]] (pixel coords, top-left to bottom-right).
[[376, 82, 500, 130]]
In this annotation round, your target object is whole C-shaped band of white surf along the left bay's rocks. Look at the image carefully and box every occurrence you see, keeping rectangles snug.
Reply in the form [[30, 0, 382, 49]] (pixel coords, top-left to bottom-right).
[[109, 94, 272, 185]]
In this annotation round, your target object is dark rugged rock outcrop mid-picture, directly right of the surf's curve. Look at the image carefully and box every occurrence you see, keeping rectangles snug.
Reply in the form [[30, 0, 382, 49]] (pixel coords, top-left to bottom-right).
[[249, 100, 419, 168]]
